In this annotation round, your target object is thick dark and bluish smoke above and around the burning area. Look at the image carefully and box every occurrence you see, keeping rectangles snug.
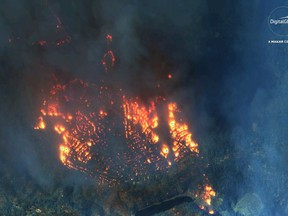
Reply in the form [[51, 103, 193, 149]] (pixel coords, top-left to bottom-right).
[[0, 0, 288, 214]]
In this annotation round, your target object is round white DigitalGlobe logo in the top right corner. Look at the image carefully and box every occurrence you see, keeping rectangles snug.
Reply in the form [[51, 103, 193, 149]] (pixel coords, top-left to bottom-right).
[[268, 6, 288, 36]]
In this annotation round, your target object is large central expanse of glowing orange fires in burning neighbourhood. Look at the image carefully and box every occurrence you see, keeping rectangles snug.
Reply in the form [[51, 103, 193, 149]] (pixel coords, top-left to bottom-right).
[[35, 80, 190, 170]]
